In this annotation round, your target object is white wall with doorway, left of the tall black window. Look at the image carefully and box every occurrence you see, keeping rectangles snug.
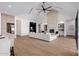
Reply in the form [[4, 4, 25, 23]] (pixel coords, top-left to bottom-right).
[[15, 16, 29, 36]]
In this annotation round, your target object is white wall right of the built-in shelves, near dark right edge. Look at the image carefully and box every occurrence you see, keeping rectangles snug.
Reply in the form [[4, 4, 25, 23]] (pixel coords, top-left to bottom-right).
[[59, 15, 75, 37]]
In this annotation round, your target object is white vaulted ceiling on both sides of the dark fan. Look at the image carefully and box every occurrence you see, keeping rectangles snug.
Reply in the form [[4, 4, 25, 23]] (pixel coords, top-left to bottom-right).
[[0, 2, 78, 16]]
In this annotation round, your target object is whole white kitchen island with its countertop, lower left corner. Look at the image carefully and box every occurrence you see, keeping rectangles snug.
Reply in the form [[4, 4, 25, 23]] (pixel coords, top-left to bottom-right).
[[0, 35, 15, 56]]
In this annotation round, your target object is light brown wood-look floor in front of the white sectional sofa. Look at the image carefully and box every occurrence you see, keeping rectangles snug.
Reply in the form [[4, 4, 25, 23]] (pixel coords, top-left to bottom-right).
[[14, 36, 77, 56]]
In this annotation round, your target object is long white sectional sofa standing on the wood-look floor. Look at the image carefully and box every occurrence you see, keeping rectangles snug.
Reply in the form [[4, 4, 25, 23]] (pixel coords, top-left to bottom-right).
[[29, 32, 57, 41]]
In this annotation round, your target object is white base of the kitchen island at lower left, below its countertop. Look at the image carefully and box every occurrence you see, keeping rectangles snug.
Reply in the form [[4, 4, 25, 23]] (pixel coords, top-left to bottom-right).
[[0, 38, 11, 56]]
